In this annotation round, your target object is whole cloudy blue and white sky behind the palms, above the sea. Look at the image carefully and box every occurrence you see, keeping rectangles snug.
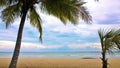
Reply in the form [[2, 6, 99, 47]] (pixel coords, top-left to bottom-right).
[[0, 0, 120, 52]]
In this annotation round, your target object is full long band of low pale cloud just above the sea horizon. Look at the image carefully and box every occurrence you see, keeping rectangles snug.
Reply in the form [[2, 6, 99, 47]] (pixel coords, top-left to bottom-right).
[[0, 41, 100, 51]]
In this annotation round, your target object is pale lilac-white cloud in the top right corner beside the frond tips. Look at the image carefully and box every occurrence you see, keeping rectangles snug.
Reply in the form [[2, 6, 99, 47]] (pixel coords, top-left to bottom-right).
[[85, 0, 120, 21]]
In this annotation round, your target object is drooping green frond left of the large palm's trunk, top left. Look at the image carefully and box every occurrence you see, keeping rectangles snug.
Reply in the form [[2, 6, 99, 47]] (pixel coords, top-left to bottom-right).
[[2, 4, 20, 28]]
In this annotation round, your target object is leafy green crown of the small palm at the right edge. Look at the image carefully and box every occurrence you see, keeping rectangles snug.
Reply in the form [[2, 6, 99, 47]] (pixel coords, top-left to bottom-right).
[[98, 29, 120, 53]]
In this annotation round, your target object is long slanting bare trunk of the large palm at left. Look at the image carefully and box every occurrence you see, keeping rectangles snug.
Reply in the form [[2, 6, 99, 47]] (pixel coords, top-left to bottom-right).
[[9, 10, 28, 68]]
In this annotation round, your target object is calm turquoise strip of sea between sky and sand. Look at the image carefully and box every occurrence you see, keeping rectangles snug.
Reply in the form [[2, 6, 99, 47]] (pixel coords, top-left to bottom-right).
[[0, 52, 120, 58]]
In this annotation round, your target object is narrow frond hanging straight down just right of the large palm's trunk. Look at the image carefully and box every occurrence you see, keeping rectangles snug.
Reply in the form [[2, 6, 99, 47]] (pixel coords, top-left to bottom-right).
[[29, 7, 42, 42]]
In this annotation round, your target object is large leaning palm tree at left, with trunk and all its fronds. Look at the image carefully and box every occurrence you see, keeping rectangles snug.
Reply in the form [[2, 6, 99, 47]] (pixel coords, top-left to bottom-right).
[[0, 0, 91, 68]]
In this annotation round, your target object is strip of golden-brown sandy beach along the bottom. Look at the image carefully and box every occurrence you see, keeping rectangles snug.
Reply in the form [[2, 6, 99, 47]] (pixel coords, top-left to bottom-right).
[[0, 58, 120, 68]]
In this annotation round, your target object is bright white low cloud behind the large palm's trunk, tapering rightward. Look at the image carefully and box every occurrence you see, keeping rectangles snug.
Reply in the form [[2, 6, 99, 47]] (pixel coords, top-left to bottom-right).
[[0, 41, 61, 50]]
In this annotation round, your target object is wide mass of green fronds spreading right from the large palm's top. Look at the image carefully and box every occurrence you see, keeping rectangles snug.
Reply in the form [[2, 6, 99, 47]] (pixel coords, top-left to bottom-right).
[[41, 0, 91, 24]]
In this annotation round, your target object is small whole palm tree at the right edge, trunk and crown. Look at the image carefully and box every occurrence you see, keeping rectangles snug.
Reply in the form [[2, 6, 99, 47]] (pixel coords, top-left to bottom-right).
[[98, 29, 120, 68]]
